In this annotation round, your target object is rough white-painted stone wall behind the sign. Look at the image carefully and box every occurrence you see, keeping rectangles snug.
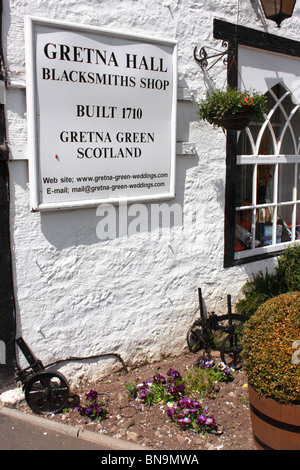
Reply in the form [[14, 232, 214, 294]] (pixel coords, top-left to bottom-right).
[[3, 0, 300, 380]]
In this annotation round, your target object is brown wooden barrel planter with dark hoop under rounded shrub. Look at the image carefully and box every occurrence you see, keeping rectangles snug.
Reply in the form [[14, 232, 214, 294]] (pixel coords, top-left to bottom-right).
[[249, 385, 300, 450]]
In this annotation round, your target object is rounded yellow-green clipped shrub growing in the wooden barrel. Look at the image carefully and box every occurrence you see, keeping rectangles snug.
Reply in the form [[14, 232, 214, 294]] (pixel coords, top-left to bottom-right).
[[243, 292, 300, 403]]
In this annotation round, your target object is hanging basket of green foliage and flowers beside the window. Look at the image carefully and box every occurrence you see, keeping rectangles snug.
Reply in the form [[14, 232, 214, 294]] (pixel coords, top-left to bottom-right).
[[199, 87, 267, 130]]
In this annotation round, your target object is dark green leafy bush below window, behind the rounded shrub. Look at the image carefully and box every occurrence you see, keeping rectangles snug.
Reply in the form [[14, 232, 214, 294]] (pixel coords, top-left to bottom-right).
[[235, 244, 300, 317]]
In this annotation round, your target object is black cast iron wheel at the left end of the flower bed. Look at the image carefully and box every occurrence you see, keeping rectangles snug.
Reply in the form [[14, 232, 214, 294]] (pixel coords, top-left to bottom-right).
[[25, 372, 69, 414]]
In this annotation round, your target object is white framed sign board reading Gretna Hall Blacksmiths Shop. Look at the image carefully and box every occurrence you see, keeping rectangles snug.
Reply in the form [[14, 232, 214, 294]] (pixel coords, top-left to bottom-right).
[[26, 17, 177, 210]]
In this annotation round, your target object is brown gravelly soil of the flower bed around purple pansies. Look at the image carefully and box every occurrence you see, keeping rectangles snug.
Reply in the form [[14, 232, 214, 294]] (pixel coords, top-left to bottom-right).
[[19, 353, 256, 451]]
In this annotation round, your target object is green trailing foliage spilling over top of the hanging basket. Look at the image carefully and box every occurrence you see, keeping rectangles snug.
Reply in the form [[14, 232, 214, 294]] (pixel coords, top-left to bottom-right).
[[198, 87, 267, 126]]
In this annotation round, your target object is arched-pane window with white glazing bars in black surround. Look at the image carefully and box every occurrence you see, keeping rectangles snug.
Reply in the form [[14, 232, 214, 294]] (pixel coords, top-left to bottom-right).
[[235, 80, 300, 260]]
